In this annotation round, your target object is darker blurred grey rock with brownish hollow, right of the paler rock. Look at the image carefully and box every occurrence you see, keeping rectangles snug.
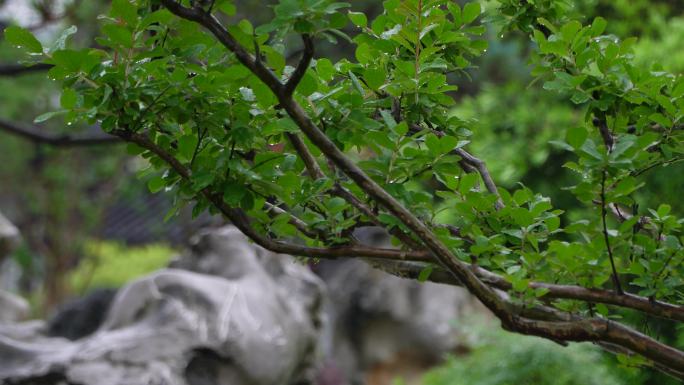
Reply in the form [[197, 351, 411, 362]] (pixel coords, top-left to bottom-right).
[[314, 228, 481, 385]]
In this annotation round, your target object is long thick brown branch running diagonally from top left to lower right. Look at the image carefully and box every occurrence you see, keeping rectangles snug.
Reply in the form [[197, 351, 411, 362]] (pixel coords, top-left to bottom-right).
[[154, 0, 684, 370]]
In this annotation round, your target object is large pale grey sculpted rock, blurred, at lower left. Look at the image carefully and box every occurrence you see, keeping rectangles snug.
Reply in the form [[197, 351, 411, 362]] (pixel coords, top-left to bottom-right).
[[0, 228, 323, 385]]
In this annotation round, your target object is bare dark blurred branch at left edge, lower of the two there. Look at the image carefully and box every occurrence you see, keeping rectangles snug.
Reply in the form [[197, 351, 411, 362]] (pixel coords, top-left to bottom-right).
[[0, 119, 121, 147]]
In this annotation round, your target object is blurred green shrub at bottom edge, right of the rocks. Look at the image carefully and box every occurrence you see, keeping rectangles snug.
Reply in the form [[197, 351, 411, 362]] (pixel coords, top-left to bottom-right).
[[423, 319, 634, 385]]
